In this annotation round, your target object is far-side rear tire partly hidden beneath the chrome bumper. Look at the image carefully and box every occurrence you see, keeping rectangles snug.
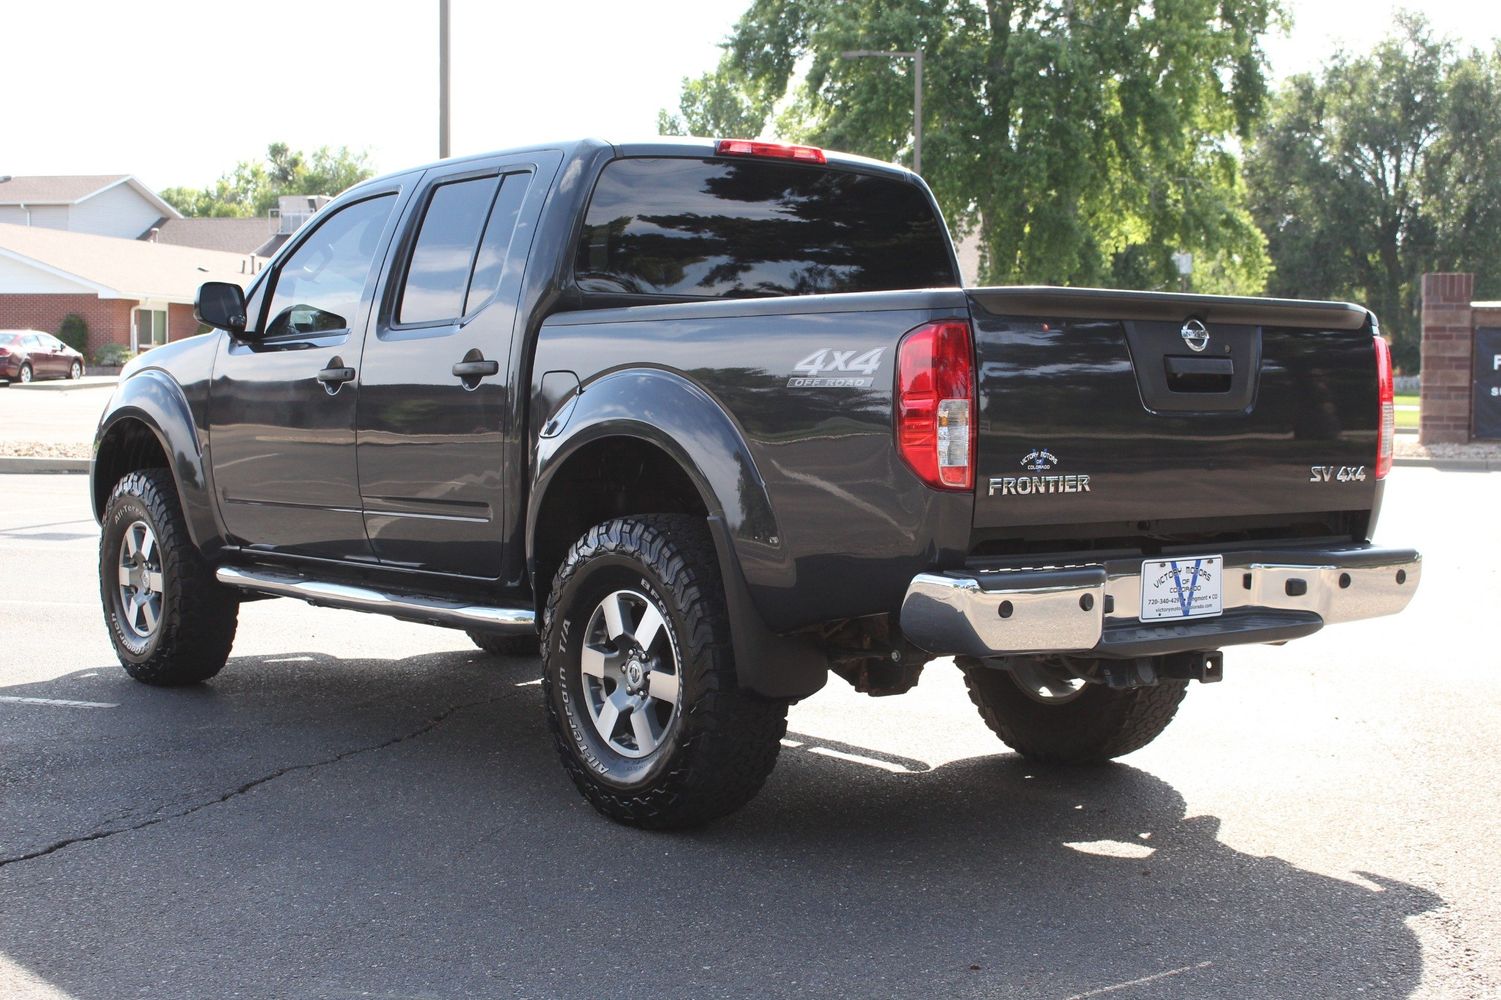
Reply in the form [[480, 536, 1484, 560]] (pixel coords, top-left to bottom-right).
[[964, 667, 1189, 764]]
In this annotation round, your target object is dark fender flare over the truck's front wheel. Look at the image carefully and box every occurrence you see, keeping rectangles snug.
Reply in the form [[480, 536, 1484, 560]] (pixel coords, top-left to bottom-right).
[[89, 368, 222, 553]]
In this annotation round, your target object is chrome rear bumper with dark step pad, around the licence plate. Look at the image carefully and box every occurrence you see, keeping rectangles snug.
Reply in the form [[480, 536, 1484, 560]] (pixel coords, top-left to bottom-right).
[[901, 545, 1423, 658]]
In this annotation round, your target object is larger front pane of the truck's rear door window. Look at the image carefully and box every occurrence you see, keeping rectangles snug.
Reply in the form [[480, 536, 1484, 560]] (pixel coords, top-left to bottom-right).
[[396, 177, 500, 323]]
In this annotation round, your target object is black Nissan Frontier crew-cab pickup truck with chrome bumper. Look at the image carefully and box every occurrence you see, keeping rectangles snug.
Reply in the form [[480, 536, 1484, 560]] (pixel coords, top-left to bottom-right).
[[92, 140, 1420, 827]]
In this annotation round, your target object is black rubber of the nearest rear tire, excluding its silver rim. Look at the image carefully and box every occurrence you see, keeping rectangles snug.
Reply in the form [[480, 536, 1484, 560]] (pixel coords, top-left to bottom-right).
[[542, 514, 788, 829]]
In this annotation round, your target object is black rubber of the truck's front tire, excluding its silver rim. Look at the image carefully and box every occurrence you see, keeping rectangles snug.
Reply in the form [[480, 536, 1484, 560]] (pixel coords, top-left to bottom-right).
[[99, 468, 240, 686]]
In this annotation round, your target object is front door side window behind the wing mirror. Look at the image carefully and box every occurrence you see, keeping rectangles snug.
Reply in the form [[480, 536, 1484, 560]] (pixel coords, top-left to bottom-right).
[[264, 194, 396, 336]]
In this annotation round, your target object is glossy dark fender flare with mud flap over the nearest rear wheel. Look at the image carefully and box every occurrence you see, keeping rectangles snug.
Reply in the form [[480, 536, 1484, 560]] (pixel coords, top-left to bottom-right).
[[527, 368, 829, 698]]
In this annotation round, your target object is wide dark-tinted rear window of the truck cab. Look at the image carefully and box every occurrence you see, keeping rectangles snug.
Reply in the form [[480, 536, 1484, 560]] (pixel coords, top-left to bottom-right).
[[575, 158, 956, 299]]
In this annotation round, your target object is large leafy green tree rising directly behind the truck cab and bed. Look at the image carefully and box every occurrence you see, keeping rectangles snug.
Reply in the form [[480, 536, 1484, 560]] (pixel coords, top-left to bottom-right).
[[683, 0, 1279, 291]]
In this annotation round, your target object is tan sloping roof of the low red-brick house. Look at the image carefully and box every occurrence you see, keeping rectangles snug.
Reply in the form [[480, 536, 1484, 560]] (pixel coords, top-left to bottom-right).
[[0, 224, 264, 302]]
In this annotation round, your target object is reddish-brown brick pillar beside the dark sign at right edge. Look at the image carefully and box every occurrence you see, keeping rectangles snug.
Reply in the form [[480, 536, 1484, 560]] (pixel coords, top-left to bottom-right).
[[1418, 275, 1475, 444]]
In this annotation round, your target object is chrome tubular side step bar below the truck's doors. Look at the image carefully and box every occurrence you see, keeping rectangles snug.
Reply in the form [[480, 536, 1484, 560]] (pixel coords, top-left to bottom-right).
[[215, 566, 537, 635]]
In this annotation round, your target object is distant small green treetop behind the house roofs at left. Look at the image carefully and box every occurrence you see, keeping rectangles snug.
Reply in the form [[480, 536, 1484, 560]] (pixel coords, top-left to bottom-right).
[[161, 143, 375, 216]]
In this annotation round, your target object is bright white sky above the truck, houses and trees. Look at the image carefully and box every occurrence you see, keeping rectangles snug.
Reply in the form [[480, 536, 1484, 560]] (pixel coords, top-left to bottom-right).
[[0, 0, 1501, 189]]
